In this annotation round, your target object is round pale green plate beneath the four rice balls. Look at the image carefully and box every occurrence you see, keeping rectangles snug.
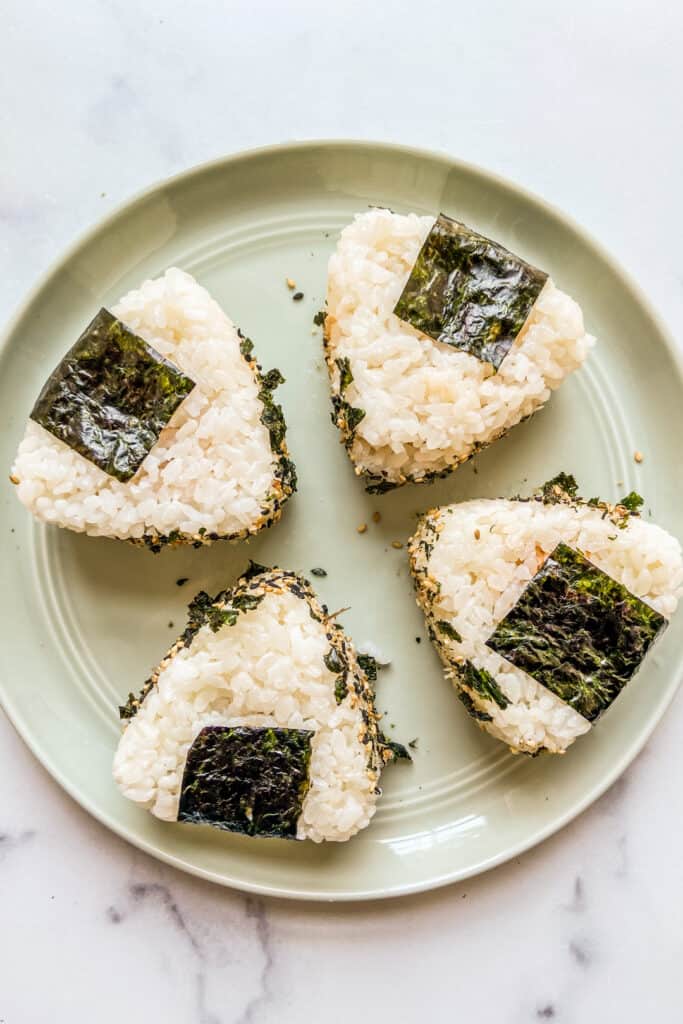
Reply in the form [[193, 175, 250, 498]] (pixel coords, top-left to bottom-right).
[[0, 142, 683, 899]]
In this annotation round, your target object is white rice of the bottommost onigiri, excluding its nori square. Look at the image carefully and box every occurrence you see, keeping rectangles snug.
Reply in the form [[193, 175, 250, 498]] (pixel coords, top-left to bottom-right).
[[114, 571, 383, 843]]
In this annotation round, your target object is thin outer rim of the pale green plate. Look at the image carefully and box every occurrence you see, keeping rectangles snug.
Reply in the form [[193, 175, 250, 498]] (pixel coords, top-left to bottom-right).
[[0, 138, 683, 903]]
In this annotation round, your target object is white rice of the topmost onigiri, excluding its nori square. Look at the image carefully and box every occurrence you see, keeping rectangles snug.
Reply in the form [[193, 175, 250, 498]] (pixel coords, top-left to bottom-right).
[[325, 209, 594, 483]]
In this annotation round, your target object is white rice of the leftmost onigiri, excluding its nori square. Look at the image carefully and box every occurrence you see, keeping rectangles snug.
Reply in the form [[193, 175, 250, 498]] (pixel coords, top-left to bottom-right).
[[12, 268, 294, 541]]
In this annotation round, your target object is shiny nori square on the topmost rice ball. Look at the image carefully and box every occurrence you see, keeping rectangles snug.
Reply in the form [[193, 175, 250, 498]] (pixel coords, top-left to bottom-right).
[[394, 214, 548, 370]]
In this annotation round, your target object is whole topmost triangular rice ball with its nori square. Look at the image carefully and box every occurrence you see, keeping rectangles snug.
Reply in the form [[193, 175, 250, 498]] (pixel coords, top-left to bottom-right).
[[324, 209, 594, 492]]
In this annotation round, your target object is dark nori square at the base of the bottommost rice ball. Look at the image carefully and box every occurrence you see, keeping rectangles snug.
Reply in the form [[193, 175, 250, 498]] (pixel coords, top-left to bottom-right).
[[178, 725, 313, 839]]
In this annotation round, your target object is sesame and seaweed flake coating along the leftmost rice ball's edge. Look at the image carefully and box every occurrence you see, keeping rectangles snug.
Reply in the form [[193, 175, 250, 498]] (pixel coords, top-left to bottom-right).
[[131, 329, 297, 554]]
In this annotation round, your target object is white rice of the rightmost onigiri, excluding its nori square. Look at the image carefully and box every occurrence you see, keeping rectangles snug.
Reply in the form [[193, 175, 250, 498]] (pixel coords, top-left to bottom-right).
[[411, 500, 683, 753]]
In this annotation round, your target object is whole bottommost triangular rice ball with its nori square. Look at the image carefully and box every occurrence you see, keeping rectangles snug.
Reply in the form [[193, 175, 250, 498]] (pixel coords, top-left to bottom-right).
[[114, 566, 407, 842]]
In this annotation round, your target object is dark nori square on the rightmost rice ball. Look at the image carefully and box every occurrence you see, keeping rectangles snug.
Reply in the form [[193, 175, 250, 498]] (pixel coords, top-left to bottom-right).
[[486, 544, 667, 722]]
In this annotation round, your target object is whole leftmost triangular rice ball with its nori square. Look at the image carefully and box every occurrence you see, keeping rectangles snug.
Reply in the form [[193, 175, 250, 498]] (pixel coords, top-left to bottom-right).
[[11, 268, 296, 550]]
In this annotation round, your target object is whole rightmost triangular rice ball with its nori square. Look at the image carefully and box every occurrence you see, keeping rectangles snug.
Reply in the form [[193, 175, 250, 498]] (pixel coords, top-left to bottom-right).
[[410, 474, 683, 754]]
